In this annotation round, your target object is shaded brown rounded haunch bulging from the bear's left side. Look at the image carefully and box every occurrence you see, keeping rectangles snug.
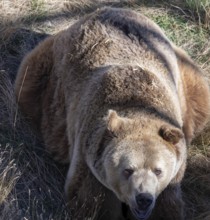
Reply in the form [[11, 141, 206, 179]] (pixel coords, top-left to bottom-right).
[[15, 36, 54, 130]]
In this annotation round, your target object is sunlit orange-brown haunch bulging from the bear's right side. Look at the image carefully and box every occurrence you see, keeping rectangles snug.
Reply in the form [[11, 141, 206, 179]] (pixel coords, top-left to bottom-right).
[[174, 47, 210, 143]]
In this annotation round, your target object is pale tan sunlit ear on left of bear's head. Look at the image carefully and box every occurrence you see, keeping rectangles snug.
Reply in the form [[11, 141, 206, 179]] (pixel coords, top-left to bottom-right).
[[106, 109, 124, 132]]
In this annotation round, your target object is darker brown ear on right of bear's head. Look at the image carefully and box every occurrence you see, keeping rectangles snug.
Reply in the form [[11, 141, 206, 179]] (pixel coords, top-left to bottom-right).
[[159, 125, 184, 144]]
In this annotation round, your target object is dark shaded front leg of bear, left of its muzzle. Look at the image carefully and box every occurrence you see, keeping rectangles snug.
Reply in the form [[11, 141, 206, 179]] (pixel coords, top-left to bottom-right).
[[66, 164, 124, 220]]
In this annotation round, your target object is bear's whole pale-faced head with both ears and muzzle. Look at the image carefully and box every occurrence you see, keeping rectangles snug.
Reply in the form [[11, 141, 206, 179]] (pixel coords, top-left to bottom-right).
[[88, 110, 186, 220]]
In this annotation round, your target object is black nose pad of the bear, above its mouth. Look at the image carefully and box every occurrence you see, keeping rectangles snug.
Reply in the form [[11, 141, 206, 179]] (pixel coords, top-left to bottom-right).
[[136, 193, 153, 211]]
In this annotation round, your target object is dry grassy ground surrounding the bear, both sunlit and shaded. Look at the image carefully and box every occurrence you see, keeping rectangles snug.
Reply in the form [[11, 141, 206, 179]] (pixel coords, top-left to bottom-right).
[[0, 0, 210, 220]]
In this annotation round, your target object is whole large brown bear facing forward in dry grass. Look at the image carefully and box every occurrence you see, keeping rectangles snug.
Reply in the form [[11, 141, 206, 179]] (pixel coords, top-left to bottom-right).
[[15, 8, 210, 220]]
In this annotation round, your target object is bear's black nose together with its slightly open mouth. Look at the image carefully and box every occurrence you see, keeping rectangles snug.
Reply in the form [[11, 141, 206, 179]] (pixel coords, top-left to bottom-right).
[[131, 193, 155, 220]]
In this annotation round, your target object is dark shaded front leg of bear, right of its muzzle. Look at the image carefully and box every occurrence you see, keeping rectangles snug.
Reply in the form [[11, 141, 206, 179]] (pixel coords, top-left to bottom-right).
[[149, 183, 184, 220]]
